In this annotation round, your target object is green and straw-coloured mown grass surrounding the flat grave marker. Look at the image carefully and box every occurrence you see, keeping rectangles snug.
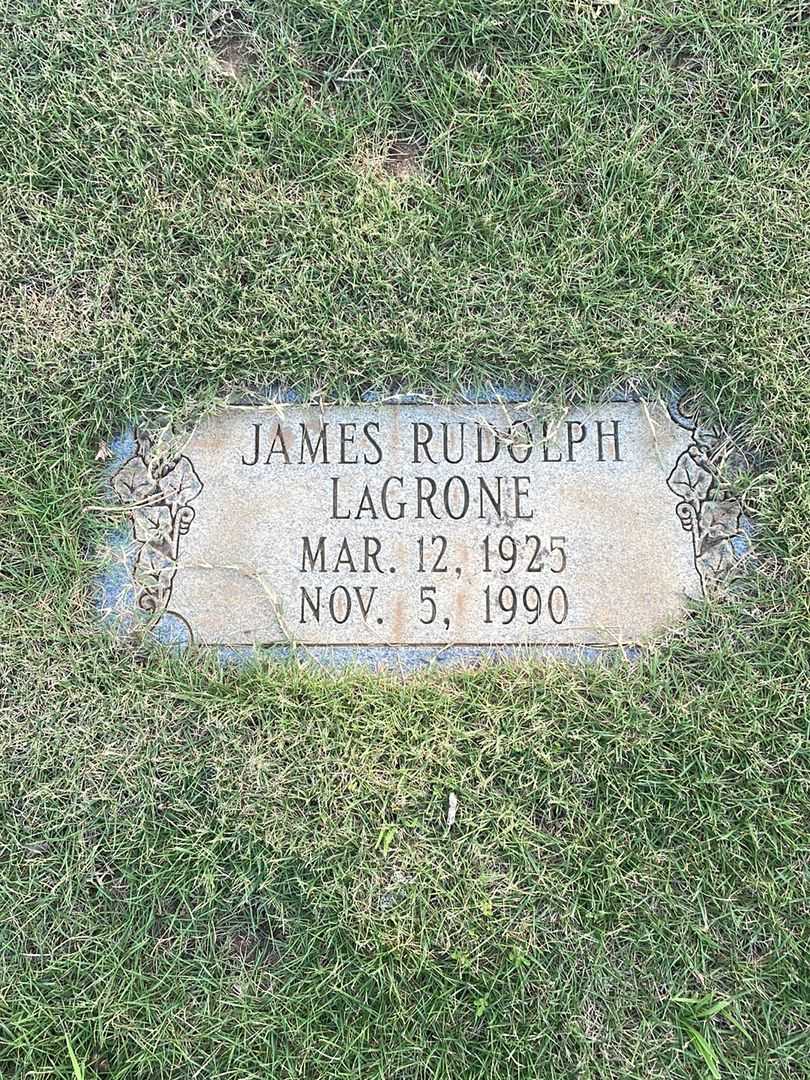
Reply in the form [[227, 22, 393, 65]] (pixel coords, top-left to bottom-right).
[[0, 0, 810, 1080]]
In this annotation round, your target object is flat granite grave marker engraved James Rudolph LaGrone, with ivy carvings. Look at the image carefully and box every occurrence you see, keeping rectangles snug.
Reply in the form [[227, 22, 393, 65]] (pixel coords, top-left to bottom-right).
[[112, 402, 740, 646]]
